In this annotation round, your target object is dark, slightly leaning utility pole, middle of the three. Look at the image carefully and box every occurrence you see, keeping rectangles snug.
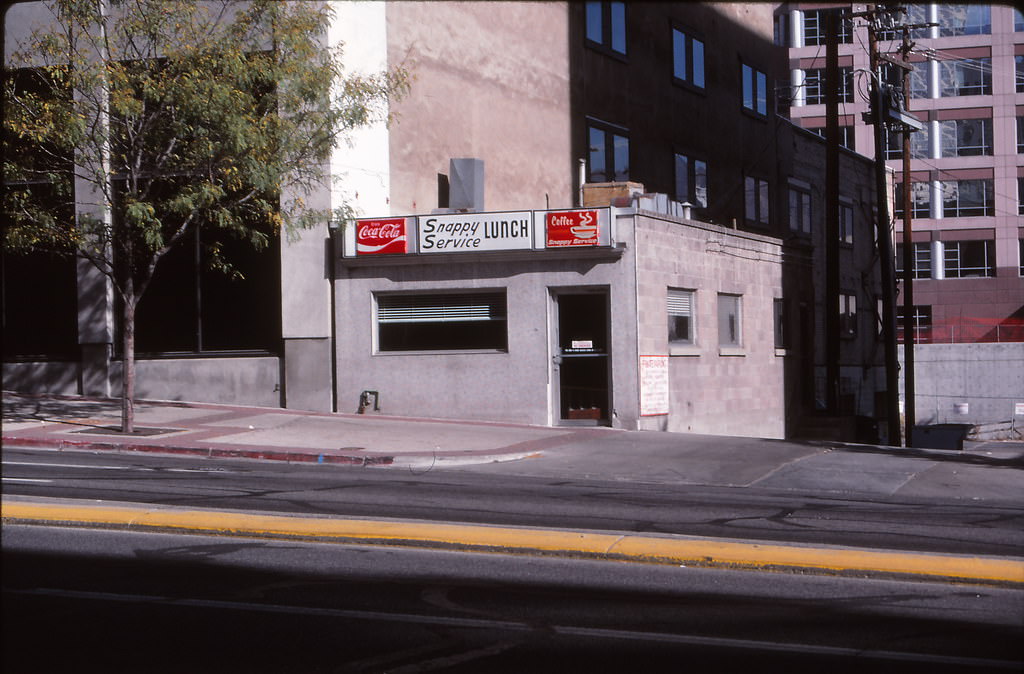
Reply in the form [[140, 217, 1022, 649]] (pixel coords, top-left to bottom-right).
[[855, 4, 902, 447]]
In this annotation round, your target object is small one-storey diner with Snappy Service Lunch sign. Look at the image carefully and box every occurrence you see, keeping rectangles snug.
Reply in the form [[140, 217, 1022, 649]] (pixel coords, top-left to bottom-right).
[[333, 195, 785, 437]]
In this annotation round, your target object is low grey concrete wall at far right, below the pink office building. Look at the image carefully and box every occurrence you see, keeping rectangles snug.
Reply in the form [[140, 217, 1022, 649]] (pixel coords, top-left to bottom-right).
[[900, 343, 1024, 425]]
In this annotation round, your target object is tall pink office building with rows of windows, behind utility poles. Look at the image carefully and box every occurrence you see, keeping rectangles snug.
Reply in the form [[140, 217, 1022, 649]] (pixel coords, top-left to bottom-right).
[[776, 3, 1024, 343]]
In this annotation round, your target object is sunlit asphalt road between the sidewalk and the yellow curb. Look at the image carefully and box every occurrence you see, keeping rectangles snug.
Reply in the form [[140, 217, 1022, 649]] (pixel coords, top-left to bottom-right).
[[3, 448, 1024, 556]]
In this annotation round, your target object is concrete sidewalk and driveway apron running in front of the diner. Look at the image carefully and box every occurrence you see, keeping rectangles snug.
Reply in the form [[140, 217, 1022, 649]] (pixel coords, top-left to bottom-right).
[[2, 385, 1024, 505]]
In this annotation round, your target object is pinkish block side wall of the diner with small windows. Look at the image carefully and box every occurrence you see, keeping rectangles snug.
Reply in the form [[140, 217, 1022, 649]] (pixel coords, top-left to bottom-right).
[[637, 217, 785, 437]]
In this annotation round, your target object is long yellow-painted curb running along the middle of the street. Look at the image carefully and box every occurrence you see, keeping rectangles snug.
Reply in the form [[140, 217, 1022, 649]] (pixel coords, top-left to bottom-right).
[[8, 500, 1024, 584]]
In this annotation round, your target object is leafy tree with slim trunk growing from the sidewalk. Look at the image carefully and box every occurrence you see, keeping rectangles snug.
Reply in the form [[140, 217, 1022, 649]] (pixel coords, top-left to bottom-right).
[[3, 0, 408, 433]]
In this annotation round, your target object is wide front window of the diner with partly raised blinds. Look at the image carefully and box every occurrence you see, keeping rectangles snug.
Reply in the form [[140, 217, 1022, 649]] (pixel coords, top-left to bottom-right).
[[377, 291, 508, 351]]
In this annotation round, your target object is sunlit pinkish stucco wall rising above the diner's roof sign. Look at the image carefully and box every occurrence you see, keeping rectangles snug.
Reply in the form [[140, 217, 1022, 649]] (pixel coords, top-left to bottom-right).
[[385, 2, 574, 215]]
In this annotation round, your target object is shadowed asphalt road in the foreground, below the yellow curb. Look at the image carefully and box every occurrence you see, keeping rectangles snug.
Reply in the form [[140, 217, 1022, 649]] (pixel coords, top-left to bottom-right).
[[8, 525, 1024, 674]]
